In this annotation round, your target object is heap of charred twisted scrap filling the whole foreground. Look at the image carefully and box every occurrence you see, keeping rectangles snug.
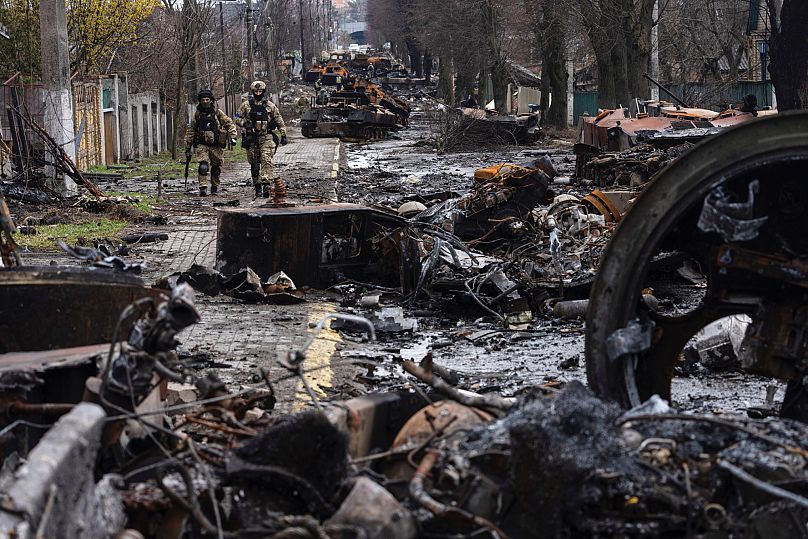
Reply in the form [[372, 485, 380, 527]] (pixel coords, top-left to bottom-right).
[[0, 278, 808, 539]]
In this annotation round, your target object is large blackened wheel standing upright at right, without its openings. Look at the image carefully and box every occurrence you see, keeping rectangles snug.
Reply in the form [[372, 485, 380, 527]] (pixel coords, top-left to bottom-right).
[[586, 113, 808, 406]]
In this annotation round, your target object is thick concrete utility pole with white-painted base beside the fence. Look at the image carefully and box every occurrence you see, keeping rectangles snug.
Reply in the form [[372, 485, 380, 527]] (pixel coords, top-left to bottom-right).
[[39, 0, 78, 195]]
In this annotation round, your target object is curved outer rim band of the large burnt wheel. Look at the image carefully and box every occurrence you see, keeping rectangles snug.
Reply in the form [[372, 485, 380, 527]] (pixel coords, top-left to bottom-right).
[[585, 113, 808, 406]]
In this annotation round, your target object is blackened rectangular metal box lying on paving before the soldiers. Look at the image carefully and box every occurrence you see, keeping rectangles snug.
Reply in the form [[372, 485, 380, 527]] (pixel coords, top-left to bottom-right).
[[216, 204, 404, 287]]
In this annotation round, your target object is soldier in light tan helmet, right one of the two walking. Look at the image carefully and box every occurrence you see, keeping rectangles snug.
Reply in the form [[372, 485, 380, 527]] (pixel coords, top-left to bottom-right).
[[239, 80, 288, 202]]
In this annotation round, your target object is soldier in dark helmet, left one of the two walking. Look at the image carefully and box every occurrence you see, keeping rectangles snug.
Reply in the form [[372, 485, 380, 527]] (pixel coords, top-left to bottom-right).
[[185, 90, 238, 197]]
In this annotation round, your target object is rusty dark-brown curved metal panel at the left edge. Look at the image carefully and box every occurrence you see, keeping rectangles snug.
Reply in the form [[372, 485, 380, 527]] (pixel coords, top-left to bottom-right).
[[0, 266, 160, 352]]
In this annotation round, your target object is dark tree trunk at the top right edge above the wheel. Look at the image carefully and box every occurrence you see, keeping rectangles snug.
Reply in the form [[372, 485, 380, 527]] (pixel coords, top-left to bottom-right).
[[769, 0, 808, 110]]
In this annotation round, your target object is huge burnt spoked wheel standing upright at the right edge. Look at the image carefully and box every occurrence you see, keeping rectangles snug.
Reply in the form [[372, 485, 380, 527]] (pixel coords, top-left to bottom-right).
[[586, 113, 808, 415]]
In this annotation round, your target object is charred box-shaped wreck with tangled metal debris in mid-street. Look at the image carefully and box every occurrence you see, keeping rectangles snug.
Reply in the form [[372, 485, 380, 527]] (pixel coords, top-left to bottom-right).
[[208, 159, 620, 331]]
